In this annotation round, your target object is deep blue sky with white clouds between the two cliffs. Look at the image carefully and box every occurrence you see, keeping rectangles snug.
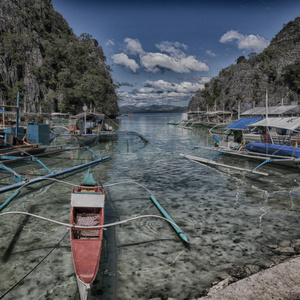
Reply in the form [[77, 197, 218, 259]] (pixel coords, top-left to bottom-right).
[[52, 0, 300, 106]]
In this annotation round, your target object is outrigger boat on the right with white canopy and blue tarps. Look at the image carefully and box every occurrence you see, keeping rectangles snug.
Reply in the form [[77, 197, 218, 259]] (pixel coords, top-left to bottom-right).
[[183, 117, 300, 175]]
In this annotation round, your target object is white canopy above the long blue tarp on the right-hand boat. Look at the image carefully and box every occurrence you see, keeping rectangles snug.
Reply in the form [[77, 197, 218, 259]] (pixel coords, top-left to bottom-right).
[[251, 117, 300, 131]]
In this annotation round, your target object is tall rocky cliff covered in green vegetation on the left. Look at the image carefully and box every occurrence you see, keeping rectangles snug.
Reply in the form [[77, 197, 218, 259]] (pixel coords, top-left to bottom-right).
[[0, 0, 120, 116]]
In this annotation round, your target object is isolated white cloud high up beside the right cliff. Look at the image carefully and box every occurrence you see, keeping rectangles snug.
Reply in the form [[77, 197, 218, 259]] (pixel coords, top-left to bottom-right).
[[220, 30, 270, 52]]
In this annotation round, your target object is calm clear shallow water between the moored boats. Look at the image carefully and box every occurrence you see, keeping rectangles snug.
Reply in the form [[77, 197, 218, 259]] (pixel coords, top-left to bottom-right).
[[0, 114, 300, 300]]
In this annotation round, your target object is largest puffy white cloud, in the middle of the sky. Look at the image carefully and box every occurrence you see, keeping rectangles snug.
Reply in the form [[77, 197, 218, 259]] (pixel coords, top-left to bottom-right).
[[140, 52, 208, 73]]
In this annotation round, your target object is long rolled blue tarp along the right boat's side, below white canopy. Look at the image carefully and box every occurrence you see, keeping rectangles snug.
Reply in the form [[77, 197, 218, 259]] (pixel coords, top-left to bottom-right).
[[245, 143, 300, 158]]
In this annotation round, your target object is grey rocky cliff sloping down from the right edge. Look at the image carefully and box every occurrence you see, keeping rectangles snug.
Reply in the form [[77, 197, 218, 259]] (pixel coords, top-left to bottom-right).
[[189, 16, 300, 111]]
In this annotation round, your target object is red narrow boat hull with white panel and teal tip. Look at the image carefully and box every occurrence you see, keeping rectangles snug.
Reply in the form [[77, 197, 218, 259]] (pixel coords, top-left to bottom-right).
[[70, 171, 105, 300]]
